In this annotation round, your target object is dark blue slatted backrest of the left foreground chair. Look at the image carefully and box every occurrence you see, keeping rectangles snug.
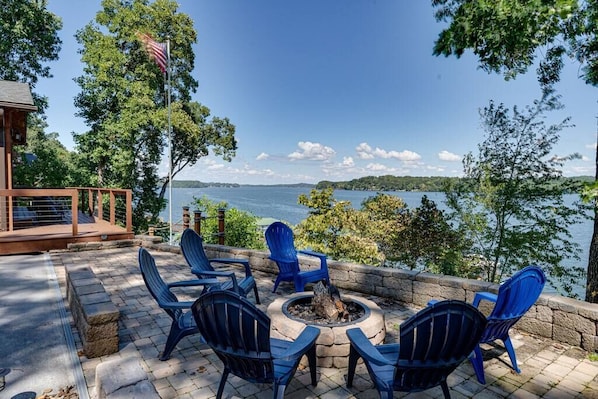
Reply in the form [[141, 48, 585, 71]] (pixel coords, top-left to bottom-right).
[[191, 290, 274, 383]]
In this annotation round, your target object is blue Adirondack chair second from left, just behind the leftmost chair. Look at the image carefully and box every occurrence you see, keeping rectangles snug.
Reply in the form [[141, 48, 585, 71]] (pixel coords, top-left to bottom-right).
[[181, 229, 260, 304]]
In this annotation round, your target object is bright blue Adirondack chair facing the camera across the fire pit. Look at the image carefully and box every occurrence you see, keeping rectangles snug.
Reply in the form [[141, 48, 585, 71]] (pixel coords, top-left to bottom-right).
[[265, 222, 330, 292]]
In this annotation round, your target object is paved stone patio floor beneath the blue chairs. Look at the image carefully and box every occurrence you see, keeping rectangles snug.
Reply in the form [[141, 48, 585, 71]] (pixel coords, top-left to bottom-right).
[[51, 246, 598, 399]]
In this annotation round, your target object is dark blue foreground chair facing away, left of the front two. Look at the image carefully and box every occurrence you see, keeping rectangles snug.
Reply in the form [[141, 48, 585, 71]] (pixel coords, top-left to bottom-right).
[[191, 290, 320, 399]]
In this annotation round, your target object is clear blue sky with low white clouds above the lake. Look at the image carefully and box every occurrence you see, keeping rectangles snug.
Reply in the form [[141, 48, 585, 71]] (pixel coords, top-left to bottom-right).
[[36, 0, 598, 184]]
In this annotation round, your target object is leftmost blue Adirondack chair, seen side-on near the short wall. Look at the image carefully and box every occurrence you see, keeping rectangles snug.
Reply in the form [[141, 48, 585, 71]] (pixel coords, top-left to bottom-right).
[[138, 248, 218, 360]]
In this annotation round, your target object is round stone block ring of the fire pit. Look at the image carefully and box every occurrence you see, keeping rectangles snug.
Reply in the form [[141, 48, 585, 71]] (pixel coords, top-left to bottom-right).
[[267, 292, 386, 368]]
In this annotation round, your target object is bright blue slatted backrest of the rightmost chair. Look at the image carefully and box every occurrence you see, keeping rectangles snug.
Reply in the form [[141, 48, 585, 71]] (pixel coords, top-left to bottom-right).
[[482, 266, 546, 342]]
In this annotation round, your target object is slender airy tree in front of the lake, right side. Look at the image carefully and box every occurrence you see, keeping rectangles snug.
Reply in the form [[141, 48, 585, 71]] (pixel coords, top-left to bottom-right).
[[445, 91, 584, 294]]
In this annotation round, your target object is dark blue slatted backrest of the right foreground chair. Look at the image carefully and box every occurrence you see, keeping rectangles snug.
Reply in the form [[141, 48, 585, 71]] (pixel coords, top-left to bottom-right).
[[395, 300, 486, 390]]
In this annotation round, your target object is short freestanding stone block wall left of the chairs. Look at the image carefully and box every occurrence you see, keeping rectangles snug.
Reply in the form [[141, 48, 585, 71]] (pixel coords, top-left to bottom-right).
[[65, 265, 120, 358]]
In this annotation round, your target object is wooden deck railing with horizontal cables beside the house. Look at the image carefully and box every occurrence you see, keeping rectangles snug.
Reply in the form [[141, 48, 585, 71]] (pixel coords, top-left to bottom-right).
[[0, 187, 133, 236]]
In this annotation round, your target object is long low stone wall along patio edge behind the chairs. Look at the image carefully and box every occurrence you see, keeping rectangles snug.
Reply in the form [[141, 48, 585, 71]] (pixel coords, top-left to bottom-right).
[[143, 241, 598, 352]]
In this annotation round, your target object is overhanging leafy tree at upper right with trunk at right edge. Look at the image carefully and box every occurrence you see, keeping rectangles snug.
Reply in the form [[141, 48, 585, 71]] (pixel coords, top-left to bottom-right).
[[432, 0, 598, 303]]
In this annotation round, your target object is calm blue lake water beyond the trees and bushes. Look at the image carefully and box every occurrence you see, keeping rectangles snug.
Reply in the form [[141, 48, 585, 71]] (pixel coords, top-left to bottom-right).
[[161, 186, 593, 298]]
